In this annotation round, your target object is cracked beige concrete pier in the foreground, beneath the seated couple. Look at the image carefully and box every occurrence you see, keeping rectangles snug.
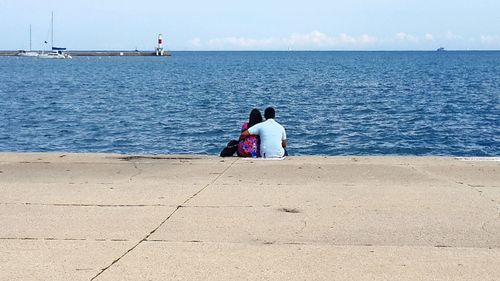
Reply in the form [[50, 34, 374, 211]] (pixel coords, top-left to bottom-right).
[[0, 153, 500, 281]]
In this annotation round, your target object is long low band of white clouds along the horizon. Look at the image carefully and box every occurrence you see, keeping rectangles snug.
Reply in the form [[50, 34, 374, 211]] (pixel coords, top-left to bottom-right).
[[188, 30, 500, 50]]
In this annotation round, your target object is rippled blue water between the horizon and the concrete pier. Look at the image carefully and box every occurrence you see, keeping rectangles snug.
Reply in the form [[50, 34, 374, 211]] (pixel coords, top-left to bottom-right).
[[0, 52, 500, 156]]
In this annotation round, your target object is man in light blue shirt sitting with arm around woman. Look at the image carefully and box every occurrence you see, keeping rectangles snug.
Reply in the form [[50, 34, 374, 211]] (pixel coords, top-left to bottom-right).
[[240, 107, 288, 158]]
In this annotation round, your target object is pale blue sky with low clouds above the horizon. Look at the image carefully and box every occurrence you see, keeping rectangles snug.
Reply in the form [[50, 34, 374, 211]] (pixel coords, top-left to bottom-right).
[[0, 0, 500, 51]]
